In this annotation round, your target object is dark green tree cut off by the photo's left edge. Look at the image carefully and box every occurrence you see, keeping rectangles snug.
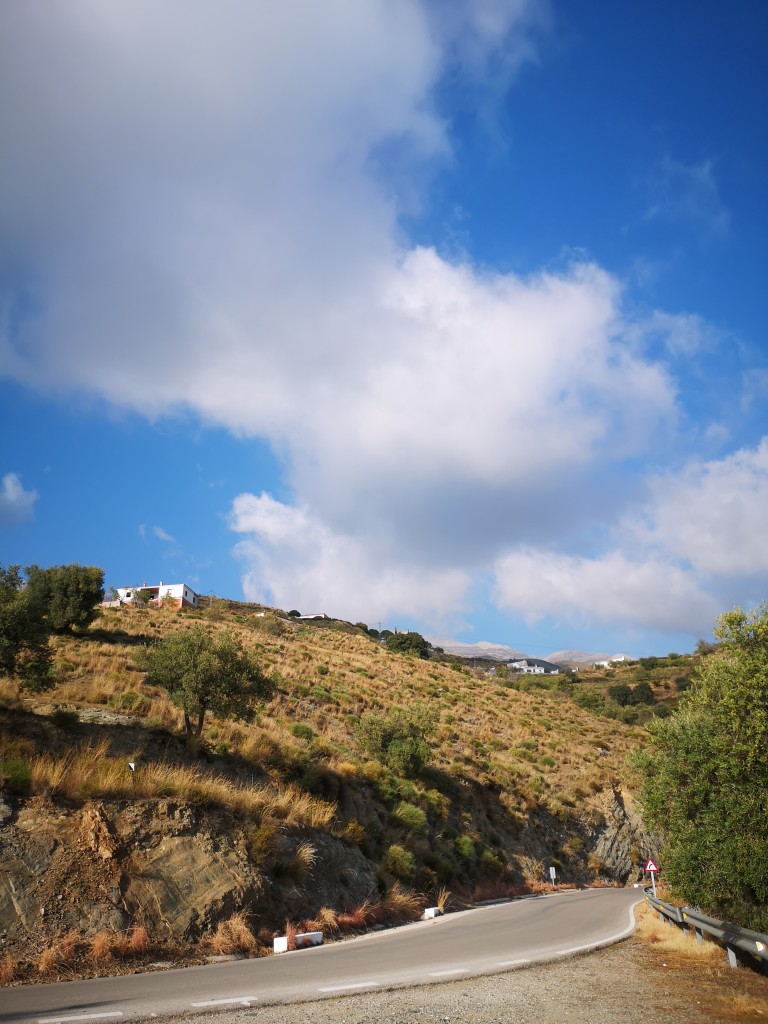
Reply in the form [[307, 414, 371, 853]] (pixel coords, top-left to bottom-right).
[[0, 565, 53, 691]]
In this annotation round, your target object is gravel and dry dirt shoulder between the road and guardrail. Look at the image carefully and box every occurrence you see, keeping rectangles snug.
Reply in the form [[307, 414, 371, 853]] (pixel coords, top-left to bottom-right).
[[186, 938, 768, 1024]]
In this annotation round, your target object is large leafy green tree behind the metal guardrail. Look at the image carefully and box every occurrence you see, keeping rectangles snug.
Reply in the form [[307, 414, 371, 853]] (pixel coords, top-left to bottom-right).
[[633, 604, 768, 931]]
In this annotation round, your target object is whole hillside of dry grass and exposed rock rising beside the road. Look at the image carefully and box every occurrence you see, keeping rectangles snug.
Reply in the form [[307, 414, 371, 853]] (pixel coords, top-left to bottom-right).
[[0, 601, 663, 982]]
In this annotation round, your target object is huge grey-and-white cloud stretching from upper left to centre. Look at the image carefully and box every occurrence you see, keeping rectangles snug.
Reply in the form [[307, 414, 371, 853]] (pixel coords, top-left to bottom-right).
[[0, 0, 757, 628]]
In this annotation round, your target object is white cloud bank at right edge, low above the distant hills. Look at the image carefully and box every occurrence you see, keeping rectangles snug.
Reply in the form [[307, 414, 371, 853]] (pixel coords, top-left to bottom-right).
[[496, 438, 768, 635]]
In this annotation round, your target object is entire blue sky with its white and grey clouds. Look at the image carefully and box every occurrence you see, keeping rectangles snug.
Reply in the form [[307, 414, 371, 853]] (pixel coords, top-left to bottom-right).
[[0, 0, 768, 655]]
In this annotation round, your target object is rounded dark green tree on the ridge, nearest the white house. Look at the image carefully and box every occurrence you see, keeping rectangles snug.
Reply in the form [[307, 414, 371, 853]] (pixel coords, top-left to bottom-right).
[[25, 562, 104, 633]]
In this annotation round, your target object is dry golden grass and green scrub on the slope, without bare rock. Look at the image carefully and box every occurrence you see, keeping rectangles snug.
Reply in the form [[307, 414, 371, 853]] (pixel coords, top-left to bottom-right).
[[0, 581, 716, 978]]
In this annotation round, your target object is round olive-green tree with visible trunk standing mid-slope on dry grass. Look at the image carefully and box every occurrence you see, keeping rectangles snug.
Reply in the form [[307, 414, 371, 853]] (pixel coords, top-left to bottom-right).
[[146, 626, 274, 738]]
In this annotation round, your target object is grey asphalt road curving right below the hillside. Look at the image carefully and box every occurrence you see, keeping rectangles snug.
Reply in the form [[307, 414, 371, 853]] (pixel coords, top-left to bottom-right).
[[0, 889, 641, 1024]]
